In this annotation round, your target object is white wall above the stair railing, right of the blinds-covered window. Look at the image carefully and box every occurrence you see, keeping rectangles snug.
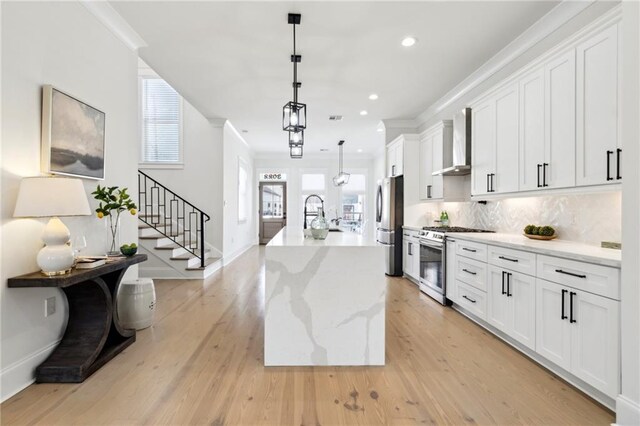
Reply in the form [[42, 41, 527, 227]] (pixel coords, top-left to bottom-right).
[[138, 99, 223, 251]]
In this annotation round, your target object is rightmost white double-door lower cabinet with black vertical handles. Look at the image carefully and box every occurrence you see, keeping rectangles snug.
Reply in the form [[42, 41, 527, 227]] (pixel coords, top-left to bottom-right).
[[536, 279, 620, 398]]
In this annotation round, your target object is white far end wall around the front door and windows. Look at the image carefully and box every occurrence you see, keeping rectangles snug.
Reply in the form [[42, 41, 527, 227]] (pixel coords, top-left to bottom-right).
[[254, 153, 384, 235]]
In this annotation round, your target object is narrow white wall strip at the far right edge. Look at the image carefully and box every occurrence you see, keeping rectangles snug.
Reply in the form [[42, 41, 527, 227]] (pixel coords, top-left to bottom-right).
[[616, 2, 640, 425]]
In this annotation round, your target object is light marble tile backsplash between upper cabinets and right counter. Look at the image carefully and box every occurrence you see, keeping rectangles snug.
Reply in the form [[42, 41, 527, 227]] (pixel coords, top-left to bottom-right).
[[416, 191, 622, 245]]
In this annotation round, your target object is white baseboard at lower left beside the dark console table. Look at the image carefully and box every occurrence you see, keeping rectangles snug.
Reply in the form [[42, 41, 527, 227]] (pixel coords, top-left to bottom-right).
[[0, 339, 60, 402]]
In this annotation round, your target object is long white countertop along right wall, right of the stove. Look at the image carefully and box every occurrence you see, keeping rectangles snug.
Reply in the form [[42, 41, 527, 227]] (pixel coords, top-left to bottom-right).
[[448, 232, 622, 268]]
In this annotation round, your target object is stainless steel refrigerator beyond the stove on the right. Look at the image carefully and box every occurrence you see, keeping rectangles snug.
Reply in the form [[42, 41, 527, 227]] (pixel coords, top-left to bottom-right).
[[376, 176, 404, 276]]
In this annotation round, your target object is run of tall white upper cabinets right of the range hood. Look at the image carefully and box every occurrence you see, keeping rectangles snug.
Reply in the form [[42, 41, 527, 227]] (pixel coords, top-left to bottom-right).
[[471, 18, 622, 197]]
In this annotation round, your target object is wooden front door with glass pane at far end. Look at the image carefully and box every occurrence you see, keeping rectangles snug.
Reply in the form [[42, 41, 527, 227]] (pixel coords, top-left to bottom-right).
[[260, 182, 287, 244]]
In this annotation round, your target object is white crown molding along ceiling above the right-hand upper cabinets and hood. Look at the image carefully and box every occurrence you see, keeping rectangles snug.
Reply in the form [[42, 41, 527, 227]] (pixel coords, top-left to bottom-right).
[[415, 0, 595, 126]]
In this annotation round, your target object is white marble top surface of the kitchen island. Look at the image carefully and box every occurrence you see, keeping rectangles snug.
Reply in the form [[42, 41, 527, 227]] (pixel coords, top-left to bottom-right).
[[267, 226, 378, 247]]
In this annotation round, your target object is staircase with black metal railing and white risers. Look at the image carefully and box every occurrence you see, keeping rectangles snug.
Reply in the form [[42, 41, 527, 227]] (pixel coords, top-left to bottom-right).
[[138, 170, 222, 279]]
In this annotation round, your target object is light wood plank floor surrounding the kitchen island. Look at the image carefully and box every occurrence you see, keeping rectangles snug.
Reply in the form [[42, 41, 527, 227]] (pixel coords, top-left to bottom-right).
[[0, 247, 614, 425]]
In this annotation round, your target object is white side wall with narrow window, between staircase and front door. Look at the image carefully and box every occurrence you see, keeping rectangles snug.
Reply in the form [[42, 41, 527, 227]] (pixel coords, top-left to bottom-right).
[[222, 122, 258, 265]]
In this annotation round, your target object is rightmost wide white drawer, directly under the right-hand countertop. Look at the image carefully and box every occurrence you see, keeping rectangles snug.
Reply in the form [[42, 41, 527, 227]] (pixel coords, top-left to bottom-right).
[[537, 255, 620, 300]]
